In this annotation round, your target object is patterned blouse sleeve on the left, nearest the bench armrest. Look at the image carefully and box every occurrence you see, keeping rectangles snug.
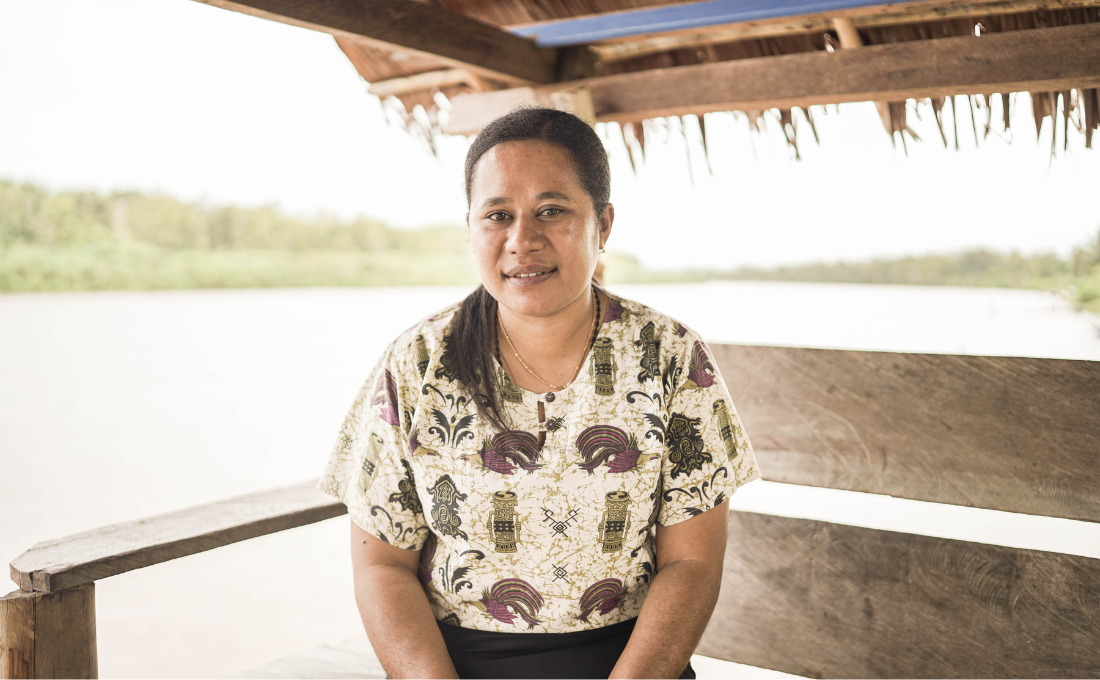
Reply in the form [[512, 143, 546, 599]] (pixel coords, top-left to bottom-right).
[[317, 344, 430, 550]]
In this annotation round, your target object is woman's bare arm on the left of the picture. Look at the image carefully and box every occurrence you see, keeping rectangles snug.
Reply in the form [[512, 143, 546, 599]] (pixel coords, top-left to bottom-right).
[[350, 522, 459, 678]]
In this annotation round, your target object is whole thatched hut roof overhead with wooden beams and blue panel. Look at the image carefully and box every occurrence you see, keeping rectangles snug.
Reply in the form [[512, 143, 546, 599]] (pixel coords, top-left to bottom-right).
[[193, 0, 1100, 149]]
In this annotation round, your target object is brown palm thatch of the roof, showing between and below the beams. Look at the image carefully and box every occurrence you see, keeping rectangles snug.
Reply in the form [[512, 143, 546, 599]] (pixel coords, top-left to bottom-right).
[[337, 0, 1100, 154]]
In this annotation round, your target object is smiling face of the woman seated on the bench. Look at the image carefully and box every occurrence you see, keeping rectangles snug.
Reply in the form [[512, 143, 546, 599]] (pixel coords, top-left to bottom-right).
[[469, 141, 615, 317]]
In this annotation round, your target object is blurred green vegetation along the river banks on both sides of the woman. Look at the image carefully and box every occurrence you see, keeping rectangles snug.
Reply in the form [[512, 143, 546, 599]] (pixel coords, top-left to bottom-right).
[[0, 176, 1100, 311]]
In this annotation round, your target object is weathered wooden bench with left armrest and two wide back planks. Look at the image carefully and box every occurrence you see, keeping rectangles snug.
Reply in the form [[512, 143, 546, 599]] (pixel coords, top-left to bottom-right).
[[0, 344, 1100, 678]]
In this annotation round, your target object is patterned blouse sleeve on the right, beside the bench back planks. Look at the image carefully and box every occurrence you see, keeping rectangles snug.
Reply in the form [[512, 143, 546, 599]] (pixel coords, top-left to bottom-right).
[[657, 330, 760, 526]]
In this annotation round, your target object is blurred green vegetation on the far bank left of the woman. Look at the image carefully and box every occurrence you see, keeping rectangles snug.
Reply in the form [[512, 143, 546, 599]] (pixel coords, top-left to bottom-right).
[[0, 182, 477, 292]]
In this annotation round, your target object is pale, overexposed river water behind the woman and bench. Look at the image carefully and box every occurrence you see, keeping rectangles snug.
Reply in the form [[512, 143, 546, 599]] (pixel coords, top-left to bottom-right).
[[0, 282, 1100, 678]]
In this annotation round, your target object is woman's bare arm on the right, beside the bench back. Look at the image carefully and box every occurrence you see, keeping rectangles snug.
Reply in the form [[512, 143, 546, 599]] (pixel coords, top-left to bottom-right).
[[611, 503, 729, 678]]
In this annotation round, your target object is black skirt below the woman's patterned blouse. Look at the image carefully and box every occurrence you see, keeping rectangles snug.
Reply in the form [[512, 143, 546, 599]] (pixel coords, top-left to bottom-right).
[[439, 618, 695, 678]]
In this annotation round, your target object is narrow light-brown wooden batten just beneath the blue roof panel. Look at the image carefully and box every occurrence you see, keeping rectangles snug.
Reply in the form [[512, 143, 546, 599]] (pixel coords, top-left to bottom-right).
[[576, 0, 1100, 62]]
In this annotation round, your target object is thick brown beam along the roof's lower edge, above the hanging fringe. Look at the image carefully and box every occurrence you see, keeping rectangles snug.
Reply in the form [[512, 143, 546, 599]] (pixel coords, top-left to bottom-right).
[[451, 24, 1100, 129]]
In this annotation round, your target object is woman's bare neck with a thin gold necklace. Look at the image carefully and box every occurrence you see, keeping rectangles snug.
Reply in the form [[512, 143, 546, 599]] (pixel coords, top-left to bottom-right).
[[497, 286, 604, 393]]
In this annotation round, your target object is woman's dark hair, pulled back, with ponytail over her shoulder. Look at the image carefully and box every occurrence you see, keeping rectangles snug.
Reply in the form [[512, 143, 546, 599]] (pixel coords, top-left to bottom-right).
[[448, 107, 612, 430]]
